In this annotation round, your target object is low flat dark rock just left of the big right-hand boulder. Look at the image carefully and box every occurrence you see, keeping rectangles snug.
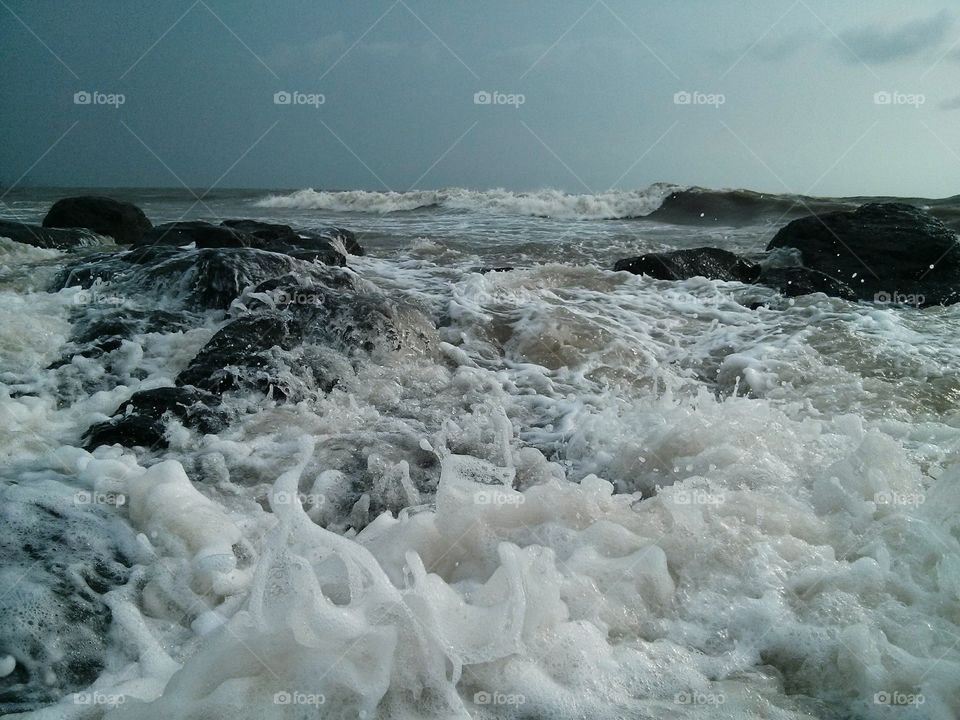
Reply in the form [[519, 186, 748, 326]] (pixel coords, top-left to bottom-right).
[[613, 247, 760, 283]]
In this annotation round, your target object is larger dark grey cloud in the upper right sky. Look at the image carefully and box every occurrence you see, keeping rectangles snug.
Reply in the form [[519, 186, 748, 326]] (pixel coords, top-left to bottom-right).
[[840, 10, 953, 64]]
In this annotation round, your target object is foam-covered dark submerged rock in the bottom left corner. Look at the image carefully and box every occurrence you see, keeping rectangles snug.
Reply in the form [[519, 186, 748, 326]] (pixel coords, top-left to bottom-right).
[[0, 477, 144, 717]]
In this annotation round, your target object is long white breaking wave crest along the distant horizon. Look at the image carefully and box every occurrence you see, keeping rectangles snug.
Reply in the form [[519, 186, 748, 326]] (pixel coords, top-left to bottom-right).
[[256, 184, 678, 220]]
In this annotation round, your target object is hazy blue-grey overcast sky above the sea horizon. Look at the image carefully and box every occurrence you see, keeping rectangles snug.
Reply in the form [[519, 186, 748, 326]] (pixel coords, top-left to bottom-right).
[[0, 0, 960, 197]]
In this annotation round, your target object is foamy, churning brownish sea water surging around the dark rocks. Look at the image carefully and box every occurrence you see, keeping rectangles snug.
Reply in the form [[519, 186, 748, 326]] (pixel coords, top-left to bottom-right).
[[0, 185, 960, 720]]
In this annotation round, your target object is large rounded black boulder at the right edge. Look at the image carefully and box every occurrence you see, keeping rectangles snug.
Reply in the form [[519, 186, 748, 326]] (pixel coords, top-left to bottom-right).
[[767, 203, 960, 306]]
